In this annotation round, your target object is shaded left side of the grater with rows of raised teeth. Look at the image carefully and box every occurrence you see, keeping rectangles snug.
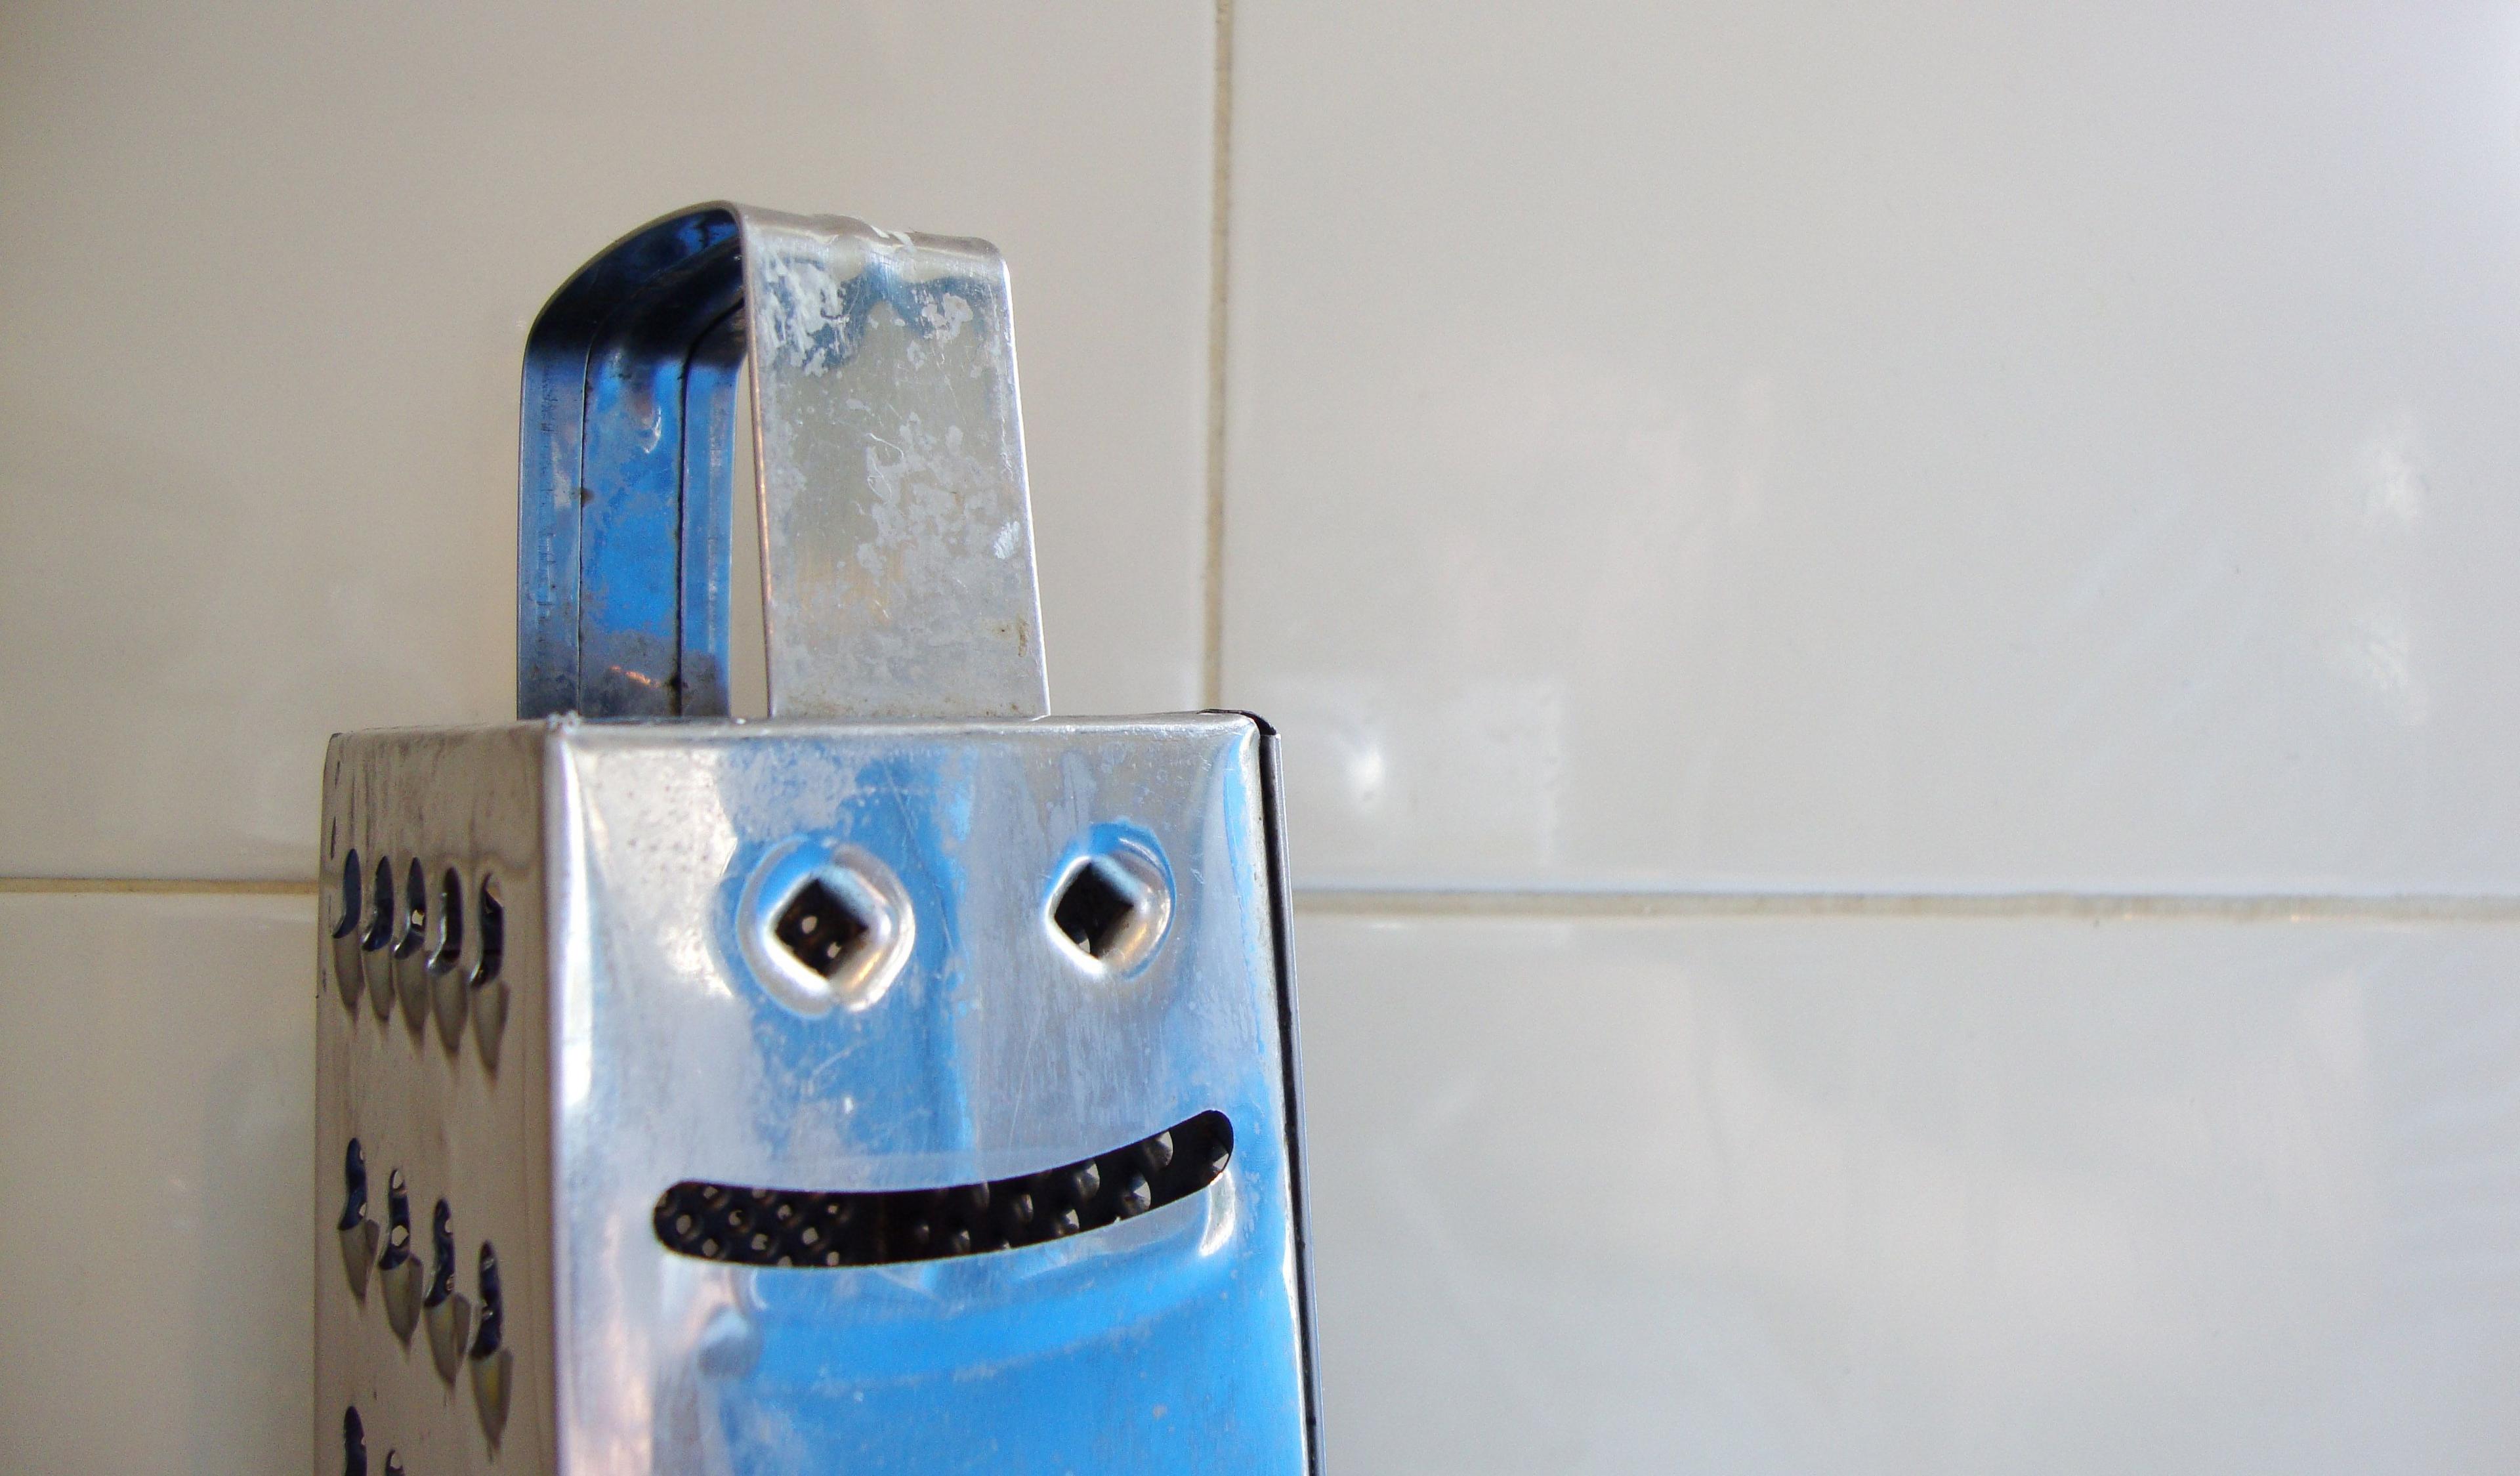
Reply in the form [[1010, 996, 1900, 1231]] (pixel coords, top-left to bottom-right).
[[310, 723, 555, 1476]]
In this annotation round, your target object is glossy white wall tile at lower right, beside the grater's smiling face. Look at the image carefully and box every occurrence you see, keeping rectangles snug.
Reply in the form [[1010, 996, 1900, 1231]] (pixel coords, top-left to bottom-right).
[[1303, 917, 2520, 1476]]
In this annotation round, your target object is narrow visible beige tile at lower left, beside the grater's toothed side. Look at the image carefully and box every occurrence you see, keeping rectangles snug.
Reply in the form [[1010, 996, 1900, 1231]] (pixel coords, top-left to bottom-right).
[[0, 894, 315, 1476]]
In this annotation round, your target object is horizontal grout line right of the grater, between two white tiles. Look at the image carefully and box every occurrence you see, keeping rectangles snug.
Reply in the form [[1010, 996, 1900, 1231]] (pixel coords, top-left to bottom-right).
[[1295, 887, 2520, 922]]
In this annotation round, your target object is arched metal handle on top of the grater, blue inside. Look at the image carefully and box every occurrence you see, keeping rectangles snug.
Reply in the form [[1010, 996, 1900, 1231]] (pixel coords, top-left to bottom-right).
[[516, 204, 1048, 718]]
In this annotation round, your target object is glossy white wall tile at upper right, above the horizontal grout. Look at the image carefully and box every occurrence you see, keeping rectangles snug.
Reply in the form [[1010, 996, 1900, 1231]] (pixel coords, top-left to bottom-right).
[[1225, 0, 2520, 892]]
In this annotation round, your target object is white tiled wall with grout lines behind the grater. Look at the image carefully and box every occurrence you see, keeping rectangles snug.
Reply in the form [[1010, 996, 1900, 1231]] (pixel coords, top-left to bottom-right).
[[0, 0, 2520, 1473]]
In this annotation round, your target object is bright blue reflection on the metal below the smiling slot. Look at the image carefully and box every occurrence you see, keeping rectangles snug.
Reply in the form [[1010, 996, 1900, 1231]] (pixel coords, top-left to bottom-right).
[[711, 1158, 1305, 1473]]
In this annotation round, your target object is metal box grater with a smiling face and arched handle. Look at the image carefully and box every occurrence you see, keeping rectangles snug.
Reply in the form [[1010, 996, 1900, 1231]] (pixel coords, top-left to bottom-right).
[[315, 204, 1318, 1476]]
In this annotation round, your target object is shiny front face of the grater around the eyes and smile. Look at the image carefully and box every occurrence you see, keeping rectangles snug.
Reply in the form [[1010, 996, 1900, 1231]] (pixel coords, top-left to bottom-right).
[[549, 715, 1311, 1476]]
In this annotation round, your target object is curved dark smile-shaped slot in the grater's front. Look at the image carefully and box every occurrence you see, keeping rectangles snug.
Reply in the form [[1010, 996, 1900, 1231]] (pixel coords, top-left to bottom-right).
[[655, 1111, 1235, 1267]]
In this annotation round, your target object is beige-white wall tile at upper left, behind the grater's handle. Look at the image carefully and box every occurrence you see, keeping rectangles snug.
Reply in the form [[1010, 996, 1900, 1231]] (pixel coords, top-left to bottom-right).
[[0, 0, 1212, 877]]
